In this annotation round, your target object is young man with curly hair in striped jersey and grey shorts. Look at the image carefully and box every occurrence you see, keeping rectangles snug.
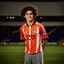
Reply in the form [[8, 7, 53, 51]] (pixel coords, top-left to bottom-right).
[[20, 5, 48, 64]]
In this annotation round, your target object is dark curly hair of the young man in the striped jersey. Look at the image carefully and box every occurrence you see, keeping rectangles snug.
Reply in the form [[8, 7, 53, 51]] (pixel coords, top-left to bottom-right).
[[21, 5, 38, 19]]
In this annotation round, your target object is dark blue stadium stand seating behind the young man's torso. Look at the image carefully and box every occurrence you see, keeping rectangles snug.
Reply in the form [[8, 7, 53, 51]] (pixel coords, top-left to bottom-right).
[[0, 26, 64, 43]]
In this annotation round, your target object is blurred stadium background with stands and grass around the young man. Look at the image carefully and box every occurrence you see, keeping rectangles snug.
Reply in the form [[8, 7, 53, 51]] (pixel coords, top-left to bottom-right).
[[0, 2, 64, 64]]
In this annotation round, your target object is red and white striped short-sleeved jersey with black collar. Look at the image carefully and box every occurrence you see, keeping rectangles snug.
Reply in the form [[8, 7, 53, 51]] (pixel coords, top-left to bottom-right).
[[20, 22, 48, 54]]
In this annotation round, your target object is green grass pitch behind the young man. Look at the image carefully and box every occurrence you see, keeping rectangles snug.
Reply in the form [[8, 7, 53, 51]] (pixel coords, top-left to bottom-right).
[[0, 45, 64, 64]]
